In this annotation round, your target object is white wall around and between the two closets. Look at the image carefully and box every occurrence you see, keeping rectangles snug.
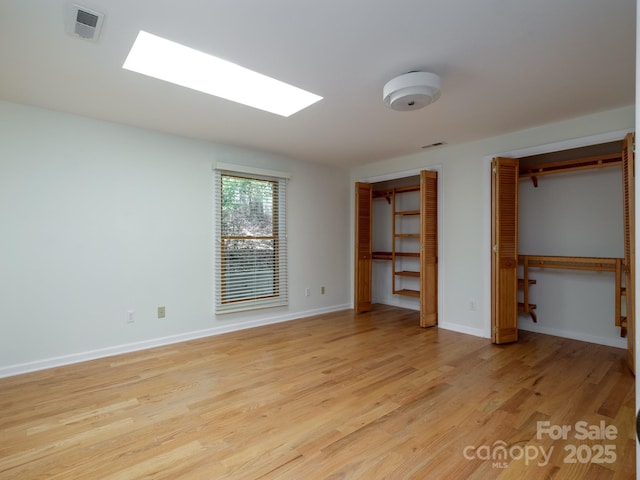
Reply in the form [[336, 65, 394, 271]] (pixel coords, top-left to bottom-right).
[[351, 106, 634, 342]]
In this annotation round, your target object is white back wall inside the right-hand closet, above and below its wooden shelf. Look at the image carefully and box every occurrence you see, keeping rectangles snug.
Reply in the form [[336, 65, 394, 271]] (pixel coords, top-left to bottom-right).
[[519, 167, 627, 348]]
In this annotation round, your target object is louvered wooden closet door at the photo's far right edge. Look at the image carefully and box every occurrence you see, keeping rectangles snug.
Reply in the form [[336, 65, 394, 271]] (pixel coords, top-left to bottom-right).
[[622, 133, 636, 373]]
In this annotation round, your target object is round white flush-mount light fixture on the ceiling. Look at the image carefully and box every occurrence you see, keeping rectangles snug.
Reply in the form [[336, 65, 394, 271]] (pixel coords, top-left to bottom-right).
[[382, 72, 440, 112]]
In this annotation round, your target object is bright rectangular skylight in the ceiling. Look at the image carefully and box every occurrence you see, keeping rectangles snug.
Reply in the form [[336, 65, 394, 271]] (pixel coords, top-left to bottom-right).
[[122, 30, 322, 117]]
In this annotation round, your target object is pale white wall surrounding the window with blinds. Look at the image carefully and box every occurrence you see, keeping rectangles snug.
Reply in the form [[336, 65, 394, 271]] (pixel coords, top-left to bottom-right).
[[0, 102, 351, 376]]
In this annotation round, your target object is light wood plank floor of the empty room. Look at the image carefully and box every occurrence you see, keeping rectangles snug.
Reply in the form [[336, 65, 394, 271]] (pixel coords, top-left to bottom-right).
[[0, 306, 635, 480]]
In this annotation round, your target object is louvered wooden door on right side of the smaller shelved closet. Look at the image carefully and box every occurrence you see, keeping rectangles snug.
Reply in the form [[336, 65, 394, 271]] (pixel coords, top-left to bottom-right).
[[420, 170, 438, 327]]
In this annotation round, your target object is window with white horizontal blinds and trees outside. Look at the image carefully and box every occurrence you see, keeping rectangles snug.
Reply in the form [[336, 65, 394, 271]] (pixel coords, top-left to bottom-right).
[[215, 169, 288, 313]]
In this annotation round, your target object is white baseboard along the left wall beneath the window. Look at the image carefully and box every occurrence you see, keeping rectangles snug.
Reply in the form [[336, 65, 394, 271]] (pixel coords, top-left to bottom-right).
[[0, 305, 352, 378]]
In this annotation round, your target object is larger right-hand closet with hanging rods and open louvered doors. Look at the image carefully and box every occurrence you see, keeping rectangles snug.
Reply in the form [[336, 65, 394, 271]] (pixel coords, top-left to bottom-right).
[[491, 134, 635, 369]]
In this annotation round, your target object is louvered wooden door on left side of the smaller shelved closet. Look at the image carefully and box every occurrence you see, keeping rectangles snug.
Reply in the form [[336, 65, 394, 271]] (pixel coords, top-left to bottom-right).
[[353, 183, 373, 313]]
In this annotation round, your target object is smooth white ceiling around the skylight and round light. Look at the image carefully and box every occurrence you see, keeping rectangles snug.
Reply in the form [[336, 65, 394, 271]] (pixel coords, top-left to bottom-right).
[[0, 0, 636, 167]]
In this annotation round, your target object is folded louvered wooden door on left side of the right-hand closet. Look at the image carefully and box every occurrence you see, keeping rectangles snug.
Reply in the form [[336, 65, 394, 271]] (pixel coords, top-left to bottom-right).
[[491, 158, 518, 343]]
